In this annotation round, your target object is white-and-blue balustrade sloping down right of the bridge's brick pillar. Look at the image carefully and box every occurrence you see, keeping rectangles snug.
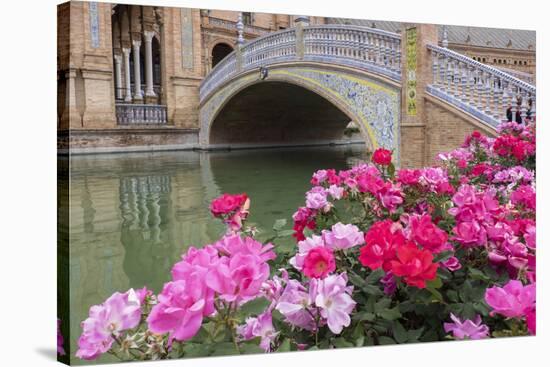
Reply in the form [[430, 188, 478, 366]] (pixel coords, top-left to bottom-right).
[[427, 45, 536, 127]]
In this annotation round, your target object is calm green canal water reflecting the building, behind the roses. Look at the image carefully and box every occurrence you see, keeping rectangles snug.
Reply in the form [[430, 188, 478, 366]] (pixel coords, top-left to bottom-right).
[[64, 145, 365, 364]]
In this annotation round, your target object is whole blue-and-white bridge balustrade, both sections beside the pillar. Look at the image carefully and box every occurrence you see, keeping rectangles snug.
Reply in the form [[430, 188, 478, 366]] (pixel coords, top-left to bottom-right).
[[199, 24, 536, 131]]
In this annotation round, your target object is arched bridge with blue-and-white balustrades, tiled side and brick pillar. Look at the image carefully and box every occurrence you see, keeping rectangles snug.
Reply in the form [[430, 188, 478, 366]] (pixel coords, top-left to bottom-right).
[[199, 23, 536, 166]]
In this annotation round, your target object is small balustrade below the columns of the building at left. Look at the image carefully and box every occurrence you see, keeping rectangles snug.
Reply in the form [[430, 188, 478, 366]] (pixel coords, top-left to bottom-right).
[[116, 103, 167, 125]]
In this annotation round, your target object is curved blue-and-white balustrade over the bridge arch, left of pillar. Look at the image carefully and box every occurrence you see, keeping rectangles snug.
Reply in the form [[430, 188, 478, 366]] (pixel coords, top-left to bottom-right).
[[200, 25, 401, 103]]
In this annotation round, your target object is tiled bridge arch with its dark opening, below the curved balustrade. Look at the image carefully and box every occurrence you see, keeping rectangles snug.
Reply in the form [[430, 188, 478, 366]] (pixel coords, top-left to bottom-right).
[[199, 65, 400, 161]]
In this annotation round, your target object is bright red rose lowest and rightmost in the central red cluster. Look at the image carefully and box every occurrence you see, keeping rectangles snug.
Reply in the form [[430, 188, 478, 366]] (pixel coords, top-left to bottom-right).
[[390, 243, 438, 288]]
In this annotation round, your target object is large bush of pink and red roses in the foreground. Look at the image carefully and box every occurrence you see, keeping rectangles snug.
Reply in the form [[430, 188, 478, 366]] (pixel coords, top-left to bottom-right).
[[77, 122, 536, 360]]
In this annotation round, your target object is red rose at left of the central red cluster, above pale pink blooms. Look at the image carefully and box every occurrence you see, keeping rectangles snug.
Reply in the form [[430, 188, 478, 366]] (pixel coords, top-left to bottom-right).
[[359, 219, 407, 271]]
